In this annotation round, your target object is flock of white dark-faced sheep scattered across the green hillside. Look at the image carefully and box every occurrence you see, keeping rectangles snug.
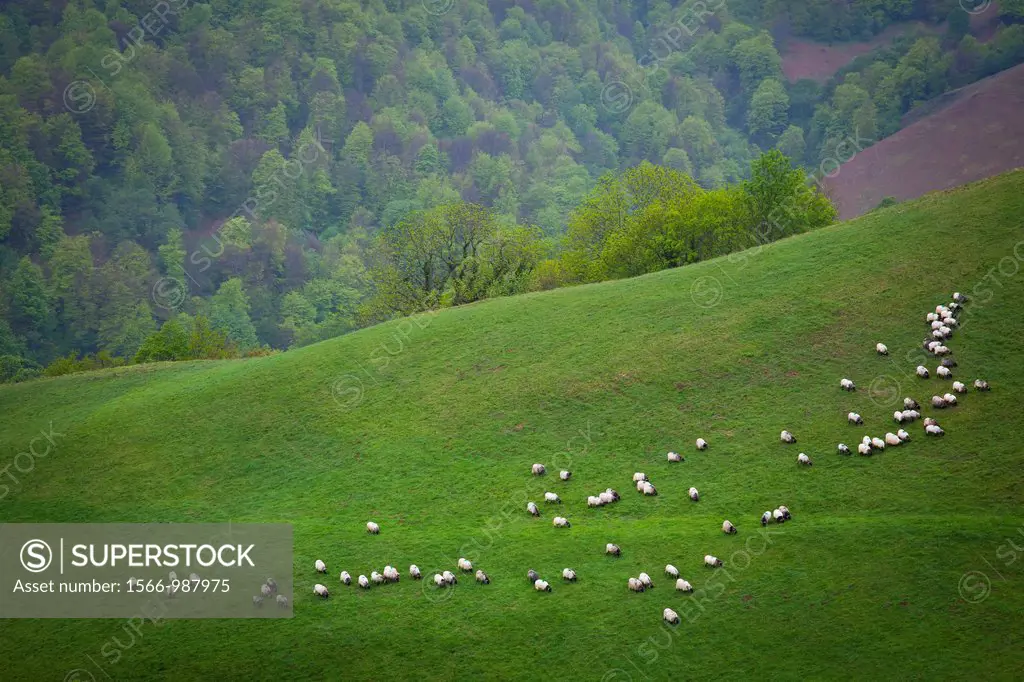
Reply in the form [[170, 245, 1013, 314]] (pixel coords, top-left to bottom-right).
[[305, 293, 989, 624]]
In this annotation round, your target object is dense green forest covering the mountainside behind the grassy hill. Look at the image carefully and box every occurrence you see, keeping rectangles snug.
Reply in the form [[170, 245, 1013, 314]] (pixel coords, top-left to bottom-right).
[[0, 0, 1024, 381]]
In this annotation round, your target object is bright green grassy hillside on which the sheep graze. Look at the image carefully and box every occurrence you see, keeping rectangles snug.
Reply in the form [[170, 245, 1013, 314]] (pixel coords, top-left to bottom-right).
[[6, 172, 1024, 680]]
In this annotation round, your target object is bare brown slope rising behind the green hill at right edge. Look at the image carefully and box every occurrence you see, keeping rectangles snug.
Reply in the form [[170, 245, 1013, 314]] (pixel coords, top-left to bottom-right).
[[825, 65, 1024, 220]]
